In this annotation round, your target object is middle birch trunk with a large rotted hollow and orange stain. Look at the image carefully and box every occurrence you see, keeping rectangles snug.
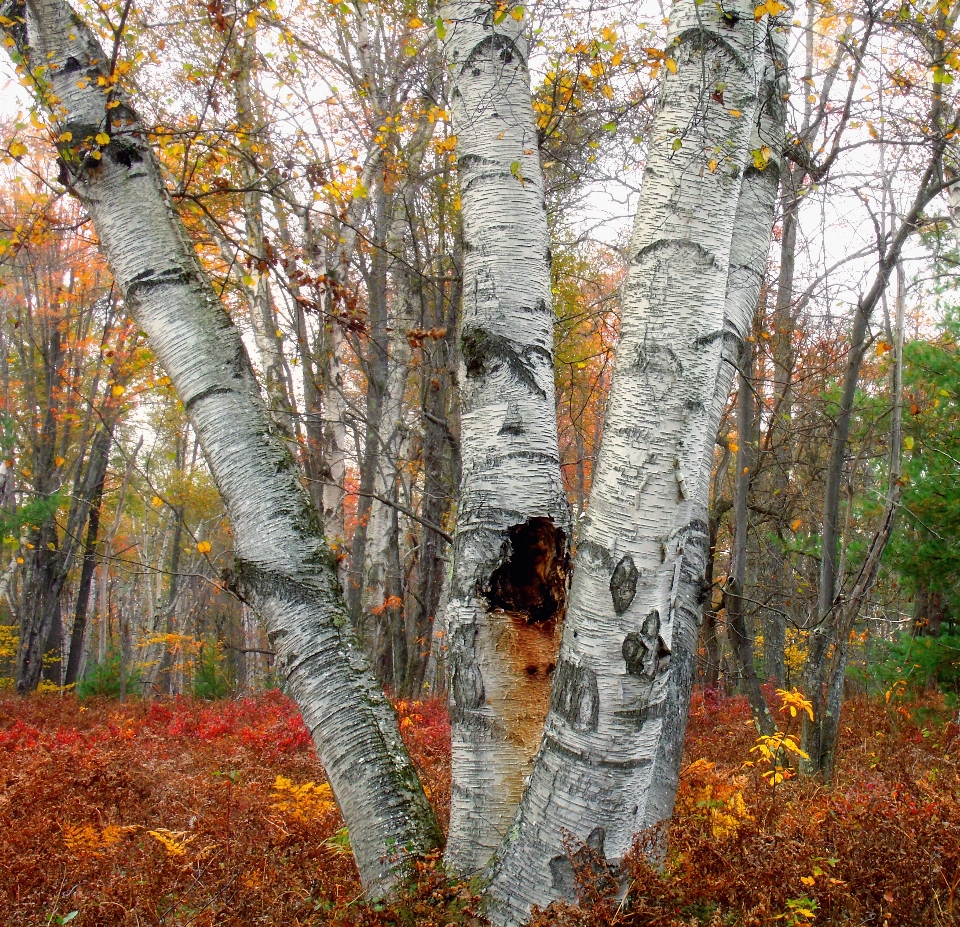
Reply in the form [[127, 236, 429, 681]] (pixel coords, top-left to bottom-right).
[[442, 0, 570, 875]]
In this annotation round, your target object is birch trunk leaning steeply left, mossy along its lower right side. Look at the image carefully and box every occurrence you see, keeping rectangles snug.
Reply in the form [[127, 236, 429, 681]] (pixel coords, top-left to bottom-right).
[[0, 0, 439, 892]]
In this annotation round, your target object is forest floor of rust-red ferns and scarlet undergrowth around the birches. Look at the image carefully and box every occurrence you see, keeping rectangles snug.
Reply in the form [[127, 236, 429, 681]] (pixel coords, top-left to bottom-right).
[[0, 692, 960, 927]]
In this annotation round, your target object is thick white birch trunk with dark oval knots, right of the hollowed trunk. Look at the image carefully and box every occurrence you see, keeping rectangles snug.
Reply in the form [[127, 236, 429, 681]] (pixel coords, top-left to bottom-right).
[[489, 0, 784, 924]]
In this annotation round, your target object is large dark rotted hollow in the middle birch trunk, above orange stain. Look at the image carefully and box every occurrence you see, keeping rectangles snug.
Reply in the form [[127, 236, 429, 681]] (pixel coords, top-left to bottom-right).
[[480, 517, 570, 624]]
